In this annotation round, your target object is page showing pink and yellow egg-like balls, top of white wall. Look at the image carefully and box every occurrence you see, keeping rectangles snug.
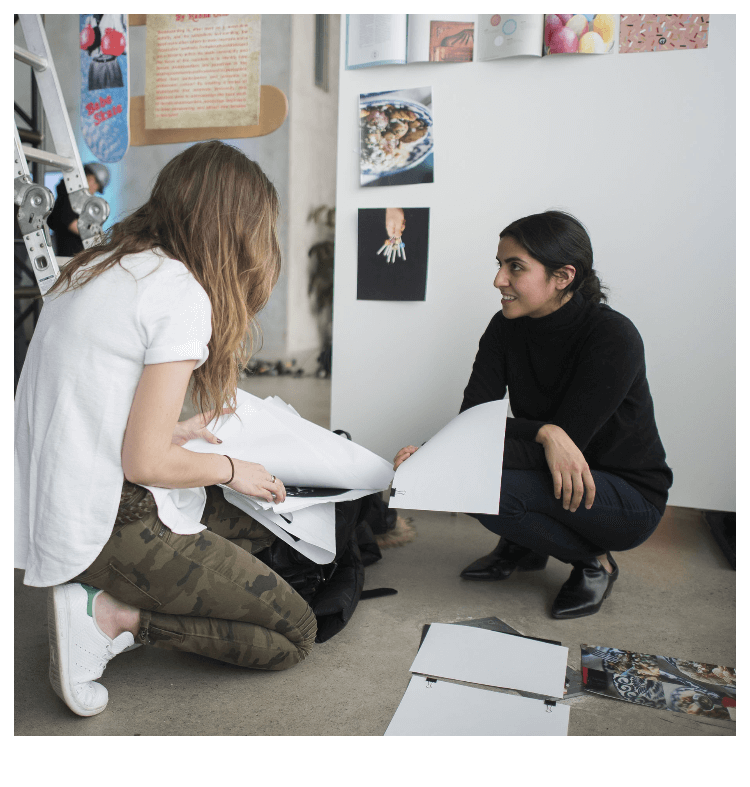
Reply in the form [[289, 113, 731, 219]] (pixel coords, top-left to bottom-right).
[[544, 14, 619, 55]]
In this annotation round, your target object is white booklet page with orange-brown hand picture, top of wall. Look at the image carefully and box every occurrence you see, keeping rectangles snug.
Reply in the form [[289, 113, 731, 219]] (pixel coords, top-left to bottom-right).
[[406, 14, 477, 63]]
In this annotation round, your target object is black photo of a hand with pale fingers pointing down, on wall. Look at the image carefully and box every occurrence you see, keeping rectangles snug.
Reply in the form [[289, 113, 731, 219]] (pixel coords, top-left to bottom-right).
[[357, 208, 430, 301]]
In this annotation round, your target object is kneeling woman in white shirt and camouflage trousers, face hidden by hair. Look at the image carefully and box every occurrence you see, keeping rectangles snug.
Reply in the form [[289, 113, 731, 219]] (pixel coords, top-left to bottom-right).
[[15, 141, 316, 716]]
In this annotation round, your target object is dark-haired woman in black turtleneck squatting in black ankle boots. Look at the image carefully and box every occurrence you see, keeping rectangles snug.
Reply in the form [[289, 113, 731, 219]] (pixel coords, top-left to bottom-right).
[[395, 211, 672, 618]]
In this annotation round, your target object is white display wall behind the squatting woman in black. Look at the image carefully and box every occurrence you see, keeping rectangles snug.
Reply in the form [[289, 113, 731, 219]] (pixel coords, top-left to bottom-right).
[[331, 14, 736, 511]]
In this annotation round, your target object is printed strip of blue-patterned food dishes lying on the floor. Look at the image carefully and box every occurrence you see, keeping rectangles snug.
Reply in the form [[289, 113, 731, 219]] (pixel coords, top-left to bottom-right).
[[581, 645, 737, 721]]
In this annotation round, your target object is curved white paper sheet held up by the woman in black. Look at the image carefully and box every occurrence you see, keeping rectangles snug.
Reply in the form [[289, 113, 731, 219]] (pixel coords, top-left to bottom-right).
[[389, 399, 508, 514]]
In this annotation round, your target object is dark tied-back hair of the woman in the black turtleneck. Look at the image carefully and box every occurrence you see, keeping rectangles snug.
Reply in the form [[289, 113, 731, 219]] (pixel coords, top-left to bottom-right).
[[500, 210, 607, 303]]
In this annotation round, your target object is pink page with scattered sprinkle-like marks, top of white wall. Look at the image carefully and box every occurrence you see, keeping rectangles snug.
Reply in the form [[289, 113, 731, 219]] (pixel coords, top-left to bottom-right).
[[620, 14, 709, 54]]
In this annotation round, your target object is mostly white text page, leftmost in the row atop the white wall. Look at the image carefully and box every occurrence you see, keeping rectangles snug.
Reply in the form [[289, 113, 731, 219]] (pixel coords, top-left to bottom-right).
[[346, 14, 406, 69]]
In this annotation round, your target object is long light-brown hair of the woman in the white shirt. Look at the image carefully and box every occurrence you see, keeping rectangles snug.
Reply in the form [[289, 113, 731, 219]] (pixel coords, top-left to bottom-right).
[[48, 140, 281, 424]]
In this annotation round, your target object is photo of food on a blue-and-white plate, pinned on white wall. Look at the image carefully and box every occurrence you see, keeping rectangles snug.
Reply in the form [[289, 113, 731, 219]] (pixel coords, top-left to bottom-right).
[[359, 87, 434, 186]]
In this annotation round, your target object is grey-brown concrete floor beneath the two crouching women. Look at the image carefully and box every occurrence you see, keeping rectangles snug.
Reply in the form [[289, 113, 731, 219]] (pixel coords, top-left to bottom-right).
[[15, 377, 736, 745]]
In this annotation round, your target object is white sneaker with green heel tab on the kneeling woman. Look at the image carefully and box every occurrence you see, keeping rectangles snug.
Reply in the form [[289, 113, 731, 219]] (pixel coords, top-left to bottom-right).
[[47, 582, 135, 716]]
